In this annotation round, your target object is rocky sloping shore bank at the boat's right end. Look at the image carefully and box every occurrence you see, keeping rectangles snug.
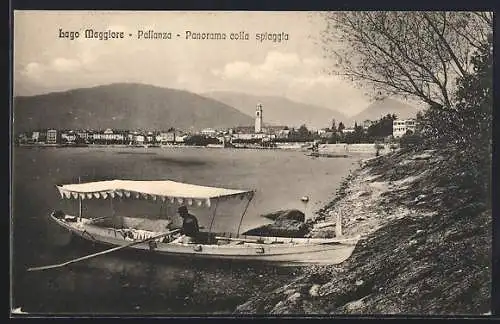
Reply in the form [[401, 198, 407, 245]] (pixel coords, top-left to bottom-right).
[[235, 149, 492, 315]]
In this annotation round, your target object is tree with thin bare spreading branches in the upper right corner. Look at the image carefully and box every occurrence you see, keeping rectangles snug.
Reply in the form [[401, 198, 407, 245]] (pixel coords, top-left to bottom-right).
[[323, 11, 493, 110]]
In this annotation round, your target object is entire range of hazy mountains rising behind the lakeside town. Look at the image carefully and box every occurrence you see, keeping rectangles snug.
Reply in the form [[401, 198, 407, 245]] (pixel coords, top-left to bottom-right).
[[14, 83, 418, 133]]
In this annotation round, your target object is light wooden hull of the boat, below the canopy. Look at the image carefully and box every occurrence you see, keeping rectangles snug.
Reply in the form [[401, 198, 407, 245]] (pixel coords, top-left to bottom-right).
[[50, 215, 357, 265]]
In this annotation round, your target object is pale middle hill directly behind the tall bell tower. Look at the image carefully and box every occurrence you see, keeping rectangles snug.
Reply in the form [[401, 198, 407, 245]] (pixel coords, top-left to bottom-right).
[[202, 91, 347, 128]]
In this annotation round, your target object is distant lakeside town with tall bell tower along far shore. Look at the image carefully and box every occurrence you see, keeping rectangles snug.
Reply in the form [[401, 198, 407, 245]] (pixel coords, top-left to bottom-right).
[[15, 104, 416, 148]]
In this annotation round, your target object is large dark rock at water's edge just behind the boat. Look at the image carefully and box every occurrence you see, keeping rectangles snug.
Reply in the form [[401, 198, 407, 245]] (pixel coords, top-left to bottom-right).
[[243, 209, 309, 237]]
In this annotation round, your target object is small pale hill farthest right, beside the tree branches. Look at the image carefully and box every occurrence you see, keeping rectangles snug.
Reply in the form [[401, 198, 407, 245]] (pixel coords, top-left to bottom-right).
[[350, 98, 418, 124]]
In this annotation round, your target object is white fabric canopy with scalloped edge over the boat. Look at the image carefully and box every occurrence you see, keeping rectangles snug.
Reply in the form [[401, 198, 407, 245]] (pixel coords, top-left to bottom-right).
[[57, 180, 254, 207]]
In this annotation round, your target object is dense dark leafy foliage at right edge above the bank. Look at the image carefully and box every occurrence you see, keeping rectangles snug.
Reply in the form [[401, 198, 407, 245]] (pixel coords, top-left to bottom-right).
[[418, 37, 493, 197]]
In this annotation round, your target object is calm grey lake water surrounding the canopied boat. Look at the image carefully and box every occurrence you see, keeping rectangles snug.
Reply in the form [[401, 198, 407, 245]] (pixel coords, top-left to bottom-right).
[[12, 148, 357, 315]]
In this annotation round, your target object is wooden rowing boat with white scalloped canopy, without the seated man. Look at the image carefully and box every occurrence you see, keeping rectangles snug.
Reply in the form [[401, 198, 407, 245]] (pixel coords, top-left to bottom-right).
[[41, 180, 359, 265]]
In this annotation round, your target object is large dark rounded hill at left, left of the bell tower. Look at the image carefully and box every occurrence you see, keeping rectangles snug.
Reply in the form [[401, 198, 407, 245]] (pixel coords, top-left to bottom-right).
[[14, 83, 253, 132]]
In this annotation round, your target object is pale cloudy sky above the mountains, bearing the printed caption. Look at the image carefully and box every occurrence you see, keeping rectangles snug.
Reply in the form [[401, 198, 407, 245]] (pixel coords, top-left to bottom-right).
[[13, 11, 376, 116]]
